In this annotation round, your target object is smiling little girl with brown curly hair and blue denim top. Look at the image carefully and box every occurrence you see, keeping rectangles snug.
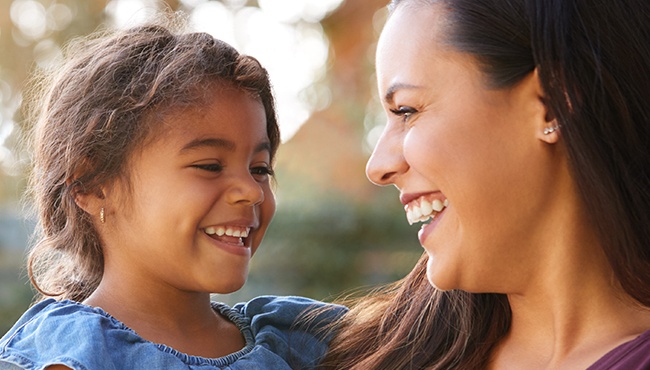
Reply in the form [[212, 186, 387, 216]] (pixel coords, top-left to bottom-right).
[[0, 21, 340, 369]]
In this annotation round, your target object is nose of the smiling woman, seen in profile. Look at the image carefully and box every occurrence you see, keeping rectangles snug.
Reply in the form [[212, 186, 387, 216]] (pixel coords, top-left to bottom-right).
[[366, 122, 408, 185]]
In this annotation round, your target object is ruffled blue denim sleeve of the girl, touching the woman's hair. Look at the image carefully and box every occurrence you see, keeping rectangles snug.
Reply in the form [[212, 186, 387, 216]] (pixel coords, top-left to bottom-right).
[[233, 296, 346, 369]]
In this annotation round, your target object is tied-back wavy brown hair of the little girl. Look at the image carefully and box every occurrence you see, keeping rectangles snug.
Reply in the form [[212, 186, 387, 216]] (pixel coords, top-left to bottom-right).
[[28, 19, 280, 301]]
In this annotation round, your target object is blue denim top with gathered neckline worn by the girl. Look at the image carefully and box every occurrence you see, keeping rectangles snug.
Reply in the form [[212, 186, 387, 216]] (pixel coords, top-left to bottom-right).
[[0, 296, 345, 370]]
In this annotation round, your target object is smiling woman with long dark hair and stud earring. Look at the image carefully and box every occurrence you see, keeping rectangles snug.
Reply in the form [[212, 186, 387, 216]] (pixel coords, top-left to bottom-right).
[[324, 0, 650, 369]]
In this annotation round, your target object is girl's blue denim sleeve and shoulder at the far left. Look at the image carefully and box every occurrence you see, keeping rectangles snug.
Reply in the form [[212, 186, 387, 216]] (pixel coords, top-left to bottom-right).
[[0, 299, 195, 370]]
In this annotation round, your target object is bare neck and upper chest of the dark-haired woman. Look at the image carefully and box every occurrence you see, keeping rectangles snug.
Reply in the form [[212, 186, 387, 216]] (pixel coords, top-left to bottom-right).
[[486, 238, 650, 370]]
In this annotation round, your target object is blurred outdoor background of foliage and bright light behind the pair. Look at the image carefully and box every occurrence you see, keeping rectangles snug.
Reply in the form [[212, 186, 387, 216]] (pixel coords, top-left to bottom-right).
[[0, 0, 422, 335]]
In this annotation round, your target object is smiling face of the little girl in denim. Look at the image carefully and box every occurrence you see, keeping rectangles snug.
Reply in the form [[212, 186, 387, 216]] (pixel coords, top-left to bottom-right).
[[98, 85, 275, 293]]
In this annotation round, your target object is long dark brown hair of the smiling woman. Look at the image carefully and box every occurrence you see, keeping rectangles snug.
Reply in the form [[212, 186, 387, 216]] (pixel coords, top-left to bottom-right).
[[323, 0, 650, 369]]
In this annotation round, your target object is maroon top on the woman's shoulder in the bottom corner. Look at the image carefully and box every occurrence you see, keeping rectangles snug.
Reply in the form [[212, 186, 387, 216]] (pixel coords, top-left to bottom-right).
[[587, 330, 650, 370]]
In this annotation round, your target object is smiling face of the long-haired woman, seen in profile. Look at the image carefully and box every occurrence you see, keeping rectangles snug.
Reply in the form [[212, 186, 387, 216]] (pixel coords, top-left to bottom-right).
[[367, 5, 556, 292]]
